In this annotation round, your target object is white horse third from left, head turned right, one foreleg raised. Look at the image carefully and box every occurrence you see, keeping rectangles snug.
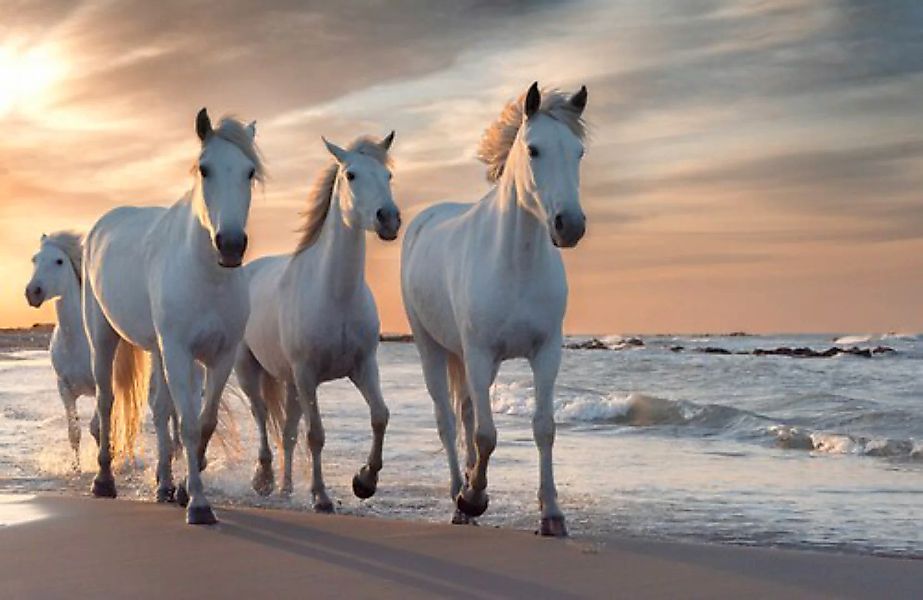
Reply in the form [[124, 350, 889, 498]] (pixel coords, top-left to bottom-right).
[[235, 132, 400, 512]]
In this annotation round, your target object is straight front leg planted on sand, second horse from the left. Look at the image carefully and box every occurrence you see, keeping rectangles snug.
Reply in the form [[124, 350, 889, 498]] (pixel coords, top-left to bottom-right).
[[161, 343, 218, 525]]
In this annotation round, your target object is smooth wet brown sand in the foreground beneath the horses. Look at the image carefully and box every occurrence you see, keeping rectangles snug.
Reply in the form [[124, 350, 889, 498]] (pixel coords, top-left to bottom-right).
[[0, 496, 923, 598]]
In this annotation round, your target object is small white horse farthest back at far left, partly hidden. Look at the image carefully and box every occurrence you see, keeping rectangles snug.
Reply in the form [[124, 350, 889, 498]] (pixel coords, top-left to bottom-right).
[[26, 231, 99, 468]]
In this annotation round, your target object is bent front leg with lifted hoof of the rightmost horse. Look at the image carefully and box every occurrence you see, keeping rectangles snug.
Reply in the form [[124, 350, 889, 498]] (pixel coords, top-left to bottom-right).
[[455, 348, 497, 517]]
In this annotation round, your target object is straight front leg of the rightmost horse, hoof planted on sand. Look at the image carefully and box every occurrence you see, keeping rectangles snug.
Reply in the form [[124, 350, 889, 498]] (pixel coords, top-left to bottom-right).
[[529, 338, 567, 537]]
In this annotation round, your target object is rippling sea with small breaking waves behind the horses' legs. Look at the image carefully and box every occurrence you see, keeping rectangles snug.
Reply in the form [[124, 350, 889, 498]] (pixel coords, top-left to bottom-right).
[[0, 333, 923, 558]]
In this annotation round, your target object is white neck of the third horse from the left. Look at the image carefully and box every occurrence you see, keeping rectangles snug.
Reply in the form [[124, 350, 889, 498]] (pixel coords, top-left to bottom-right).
[[293, 189, 365, 300]]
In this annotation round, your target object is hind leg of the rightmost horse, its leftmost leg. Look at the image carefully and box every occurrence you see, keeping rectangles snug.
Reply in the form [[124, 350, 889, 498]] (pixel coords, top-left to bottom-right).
[[410, 318, 467, 522]]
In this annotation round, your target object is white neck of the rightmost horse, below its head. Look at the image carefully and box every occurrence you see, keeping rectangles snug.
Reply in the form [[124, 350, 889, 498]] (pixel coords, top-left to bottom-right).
[[484, 176, 551, 273]]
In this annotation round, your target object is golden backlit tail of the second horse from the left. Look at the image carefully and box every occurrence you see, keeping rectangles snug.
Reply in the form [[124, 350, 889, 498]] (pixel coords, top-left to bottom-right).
[[110, 340, 151, 463]]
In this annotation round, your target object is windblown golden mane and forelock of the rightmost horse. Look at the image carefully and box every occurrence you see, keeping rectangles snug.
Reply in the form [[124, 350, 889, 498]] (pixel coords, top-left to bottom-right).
[[478, 89, 586, 183]]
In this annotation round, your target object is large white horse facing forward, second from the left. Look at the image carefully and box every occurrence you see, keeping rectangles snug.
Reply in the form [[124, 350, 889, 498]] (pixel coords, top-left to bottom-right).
[[83, 108, 263, 524]]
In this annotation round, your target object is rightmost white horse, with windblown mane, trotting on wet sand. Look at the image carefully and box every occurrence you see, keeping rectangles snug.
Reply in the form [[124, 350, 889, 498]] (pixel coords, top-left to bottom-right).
[[401, 84, 587, 536]]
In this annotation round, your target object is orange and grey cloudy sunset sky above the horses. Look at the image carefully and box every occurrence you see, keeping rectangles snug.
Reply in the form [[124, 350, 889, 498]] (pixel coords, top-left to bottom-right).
[[0, 0, 923, 333]]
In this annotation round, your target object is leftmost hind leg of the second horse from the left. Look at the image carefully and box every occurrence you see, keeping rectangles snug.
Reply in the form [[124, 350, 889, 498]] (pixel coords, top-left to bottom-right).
[[84, 286, 119, 498]]
